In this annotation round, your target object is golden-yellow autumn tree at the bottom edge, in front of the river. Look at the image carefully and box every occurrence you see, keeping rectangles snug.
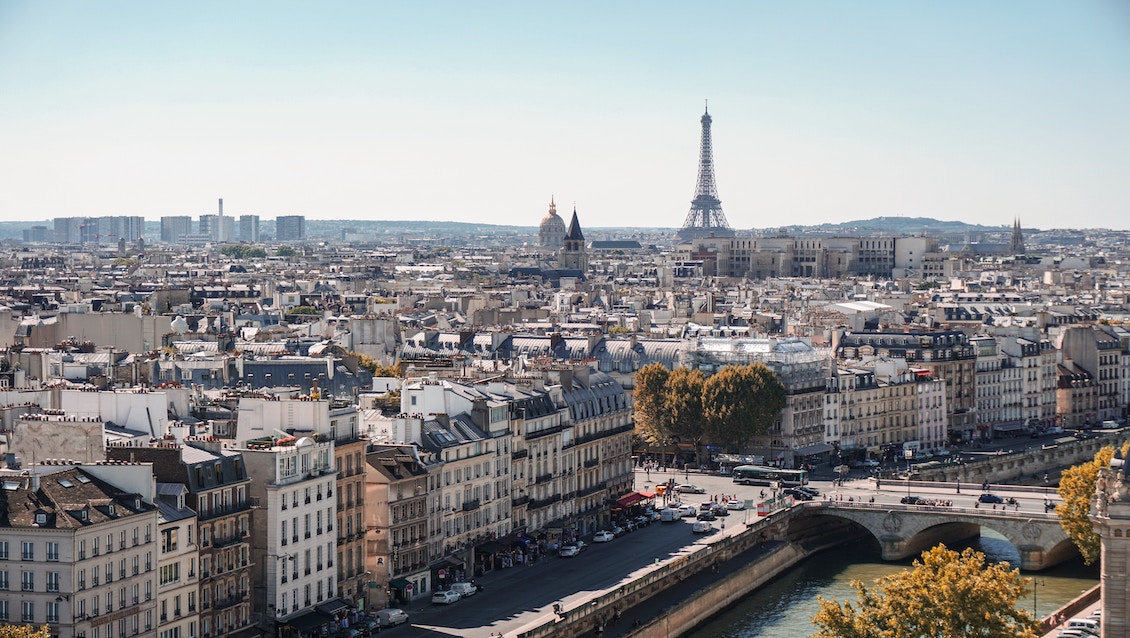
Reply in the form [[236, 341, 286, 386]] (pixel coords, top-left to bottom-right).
[[811, 544, 1038, 638]]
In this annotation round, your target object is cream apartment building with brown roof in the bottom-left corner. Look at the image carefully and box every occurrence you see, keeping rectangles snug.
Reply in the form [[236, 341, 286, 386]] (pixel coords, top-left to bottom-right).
[[0, 462, 158, 638]]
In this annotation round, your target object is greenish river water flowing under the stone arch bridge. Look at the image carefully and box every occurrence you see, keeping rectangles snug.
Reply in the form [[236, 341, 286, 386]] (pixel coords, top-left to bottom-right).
[[687, 530, 1098, 638]]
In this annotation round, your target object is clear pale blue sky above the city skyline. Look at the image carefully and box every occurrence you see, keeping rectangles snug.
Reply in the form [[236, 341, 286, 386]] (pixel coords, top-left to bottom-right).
[[0, 0, 1130, 229]]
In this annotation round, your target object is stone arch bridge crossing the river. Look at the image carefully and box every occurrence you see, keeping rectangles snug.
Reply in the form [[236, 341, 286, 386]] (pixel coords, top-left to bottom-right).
[[788, 501, 1078, 571]]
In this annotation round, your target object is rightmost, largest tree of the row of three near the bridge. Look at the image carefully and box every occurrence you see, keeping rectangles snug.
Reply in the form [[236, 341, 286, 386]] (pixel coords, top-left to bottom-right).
[[703, 364, 786, 452]]
